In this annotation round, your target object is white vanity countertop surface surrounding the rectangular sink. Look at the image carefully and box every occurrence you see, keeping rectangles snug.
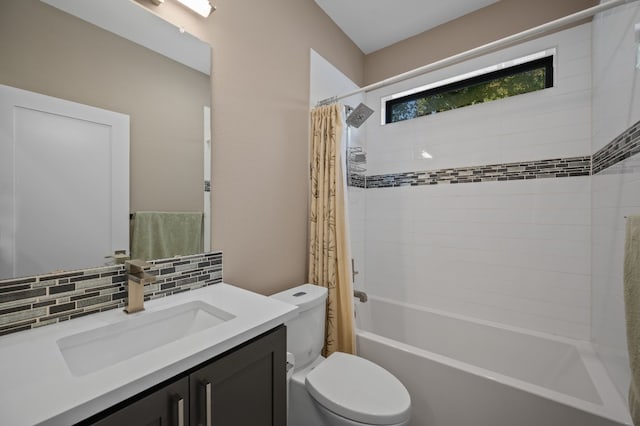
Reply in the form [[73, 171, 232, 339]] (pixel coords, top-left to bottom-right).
[[0, 284, 297, 426]]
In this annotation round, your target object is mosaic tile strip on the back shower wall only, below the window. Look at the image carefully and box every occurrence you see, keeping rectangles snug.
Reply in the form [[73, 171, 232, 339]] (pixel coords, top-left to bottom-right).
[[365, 156, 591, 188]]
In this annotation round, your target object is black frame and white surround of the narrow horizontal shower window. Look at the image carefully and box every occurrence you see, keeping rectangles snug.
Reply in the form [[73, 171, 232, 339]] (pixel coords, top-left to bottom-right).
[[380, 48, 556, 125]]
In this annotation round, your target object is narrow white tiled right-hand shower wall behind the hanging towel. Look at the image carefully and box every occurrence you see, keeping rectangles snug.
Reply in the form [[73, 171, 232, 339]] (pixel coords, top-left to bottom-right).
[[591, 2, 640, 396]]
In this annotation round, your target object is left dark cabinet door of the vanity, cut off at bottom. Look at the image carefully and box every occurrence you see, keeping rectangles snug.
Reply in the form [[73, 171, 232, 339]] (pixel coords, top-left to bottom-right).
[[93, 377, 189, 426]]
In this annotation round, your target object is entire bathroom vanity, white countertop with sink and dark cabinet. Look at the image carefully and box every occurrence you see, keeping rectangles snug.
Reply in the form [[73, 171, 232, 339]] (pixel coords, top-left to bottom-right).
[[0, 284, 297, 426]]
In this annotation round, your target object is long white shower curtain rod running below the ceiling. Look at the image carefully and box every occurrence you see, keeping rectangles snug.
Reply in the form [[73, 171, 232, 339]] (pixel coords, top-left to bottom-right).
[[318, 0, 637, 105]]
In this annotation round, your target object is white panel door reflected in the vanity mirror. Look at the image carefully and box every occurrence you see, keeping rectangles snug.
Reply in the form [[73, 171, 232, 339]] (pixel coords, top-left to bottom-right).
[[0, 85, 129, 279]]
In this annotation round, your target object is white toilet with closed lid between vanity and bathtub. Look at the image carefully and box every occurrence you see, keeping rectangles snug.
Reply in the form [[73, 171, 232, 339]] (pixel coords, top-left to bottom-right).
[[271, 284, 411, 426]]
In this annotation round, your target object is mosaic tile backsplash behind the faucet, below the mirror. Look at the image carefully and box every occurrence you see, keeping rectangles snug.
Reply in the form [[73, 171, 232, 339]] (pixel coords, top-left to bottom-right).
[[0, 252, 222, 335]]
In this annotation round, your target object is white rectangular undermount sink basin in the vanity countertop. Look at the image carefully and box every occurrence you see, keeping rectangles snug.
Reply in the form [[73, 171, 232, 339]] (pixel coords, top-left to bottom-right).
[[57, 301, 235, 376]]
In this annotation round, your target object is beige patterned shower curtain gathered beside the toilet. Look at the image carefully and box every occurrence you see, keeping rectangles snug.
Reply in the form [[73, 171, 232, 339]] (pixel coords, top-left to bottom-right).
[[309, 104, 355, 356]]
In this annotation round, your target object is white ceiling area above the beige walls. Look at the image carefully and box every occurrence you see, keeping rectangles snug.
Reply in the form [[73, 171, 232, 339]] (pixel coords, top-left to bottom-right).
[[315, 0, 498, 53]]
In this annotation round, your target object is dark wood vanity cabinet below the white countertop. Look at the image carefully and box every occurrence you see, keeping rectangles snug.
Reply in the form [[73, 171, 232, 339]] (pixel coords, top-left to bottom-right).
[[79, 326, 287, 426]]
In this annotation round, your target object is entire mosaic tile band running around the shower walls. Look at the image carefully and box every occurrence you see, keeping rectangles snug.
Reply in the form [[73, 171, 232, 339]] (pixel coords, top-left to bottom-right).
[[348, 121, 640, 188]]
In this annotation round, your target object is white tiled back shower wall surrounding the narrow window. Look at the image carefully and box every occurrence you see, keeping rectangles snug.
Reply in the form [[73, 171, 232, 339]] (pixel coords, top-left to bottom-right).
[[360, 24, 592, 339]]
